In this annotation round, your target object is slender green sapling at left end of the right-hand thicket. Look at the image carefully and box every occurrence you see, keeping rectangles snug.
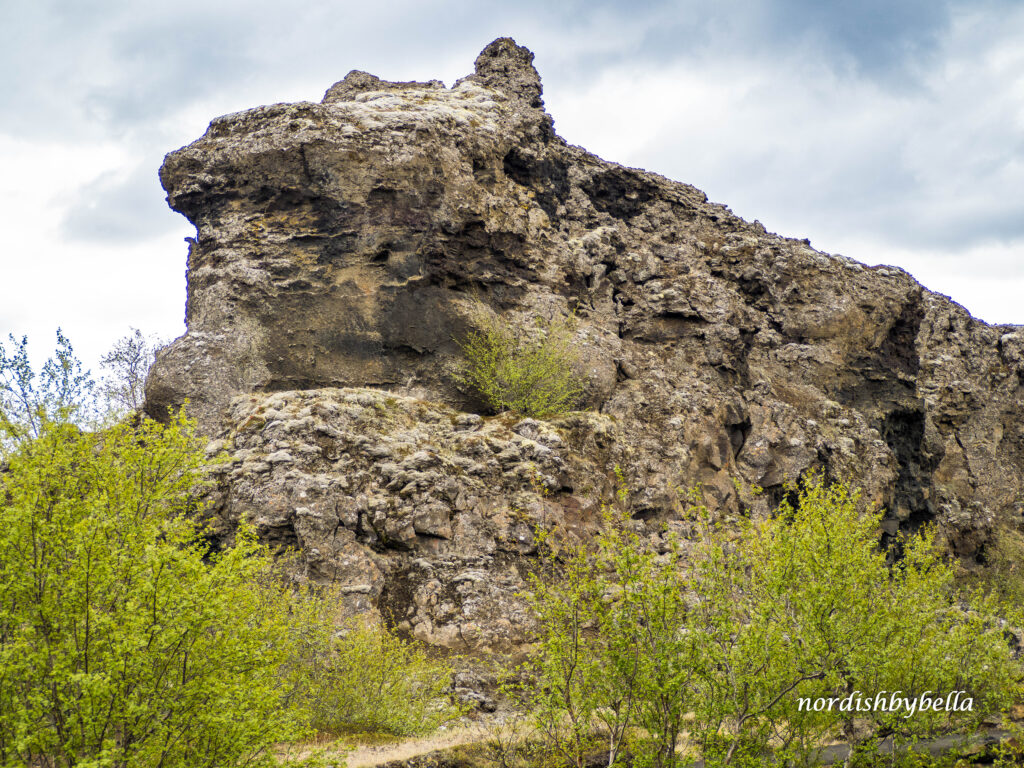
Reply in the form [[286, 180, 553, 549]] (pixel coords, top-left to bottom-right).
[[529, 487, 701, 766]]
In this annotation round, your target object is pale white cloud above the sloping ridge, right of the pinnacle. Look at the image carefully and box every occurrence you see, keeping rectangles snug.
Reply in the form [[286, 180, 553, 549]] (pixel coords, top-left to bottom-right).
[[548, 1, 1024, 323]]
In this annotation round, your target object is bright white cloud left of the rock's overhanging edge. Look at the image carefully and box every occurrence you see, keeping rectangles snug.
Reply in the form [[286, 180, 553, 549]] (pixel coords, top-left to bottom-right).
[[0, 136, 193, 366]]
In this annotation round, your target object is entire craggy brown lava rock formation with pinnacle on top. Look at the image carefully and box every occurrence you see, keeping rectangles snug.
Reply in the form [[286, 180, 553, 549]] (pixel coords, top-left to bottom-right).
[[146, 39, 1024, 647]]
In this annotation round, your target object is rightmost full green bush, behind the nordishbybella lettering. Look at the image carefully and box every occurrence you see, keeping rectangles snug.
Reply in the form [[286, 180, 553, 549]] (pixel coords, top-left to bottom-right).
[[729, 478, 1020, 765]]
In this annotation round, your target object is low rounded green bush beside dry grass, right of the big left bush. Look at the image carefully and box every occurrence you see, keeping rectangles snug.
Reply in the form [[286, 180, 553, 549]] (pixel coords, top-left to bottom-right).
[[303, 622, 463, 736]]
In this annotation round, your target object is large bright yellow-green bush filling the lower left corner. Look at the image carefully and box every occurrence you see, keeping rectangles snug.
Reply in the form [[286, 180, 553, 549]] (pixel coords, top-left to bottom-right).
[[0, 417, 327, 768]]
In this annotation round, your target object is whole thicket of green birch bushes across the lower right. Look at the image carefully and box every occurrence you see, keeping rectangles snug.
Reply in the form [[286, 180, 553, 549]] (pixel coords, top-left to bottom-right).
[[528, 479, 1021, 767]]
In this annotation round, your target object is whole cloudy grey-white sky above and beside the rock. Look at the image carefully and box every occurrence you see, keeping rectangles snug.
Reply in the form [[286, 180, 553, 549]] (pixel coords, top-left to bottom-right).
[[0, 0, 1024, 366]]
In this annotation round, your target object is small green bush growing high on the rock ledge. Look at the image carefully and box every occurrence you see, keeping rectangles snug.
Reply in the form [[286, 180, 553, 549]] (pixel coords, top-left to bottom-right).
[[460, 303, 583, 419]]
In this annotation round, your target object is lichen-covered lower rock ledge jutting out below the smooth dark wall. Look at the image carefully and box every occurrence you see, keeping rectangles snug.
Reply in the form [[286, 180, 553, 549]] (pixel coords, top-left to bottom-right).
[[201, 388, 614, 651]]
